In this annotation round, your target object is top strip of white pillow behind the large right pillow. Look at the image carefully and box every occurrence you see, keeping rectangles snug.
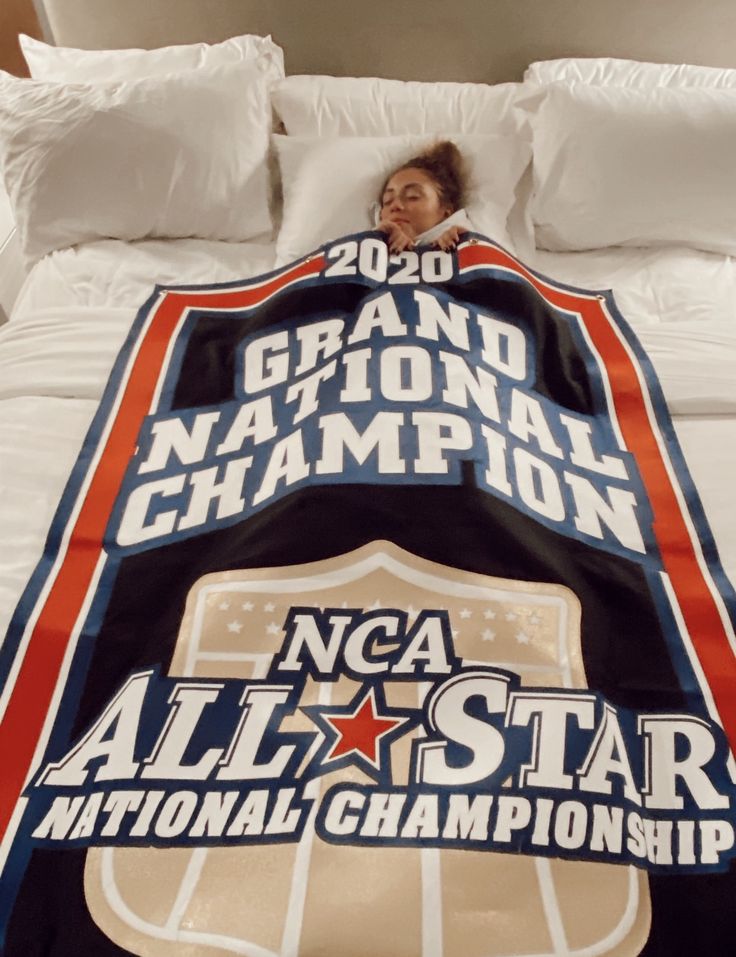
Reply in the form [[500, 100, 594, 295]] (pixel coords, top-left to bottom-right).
[[524, 57, 736, 90]]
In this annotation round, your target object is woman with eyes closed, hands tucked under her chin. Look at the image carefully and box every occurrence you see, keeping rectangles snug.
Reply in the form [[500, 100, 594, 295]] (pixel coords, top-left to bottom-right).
[[378, 141, 470, 253]]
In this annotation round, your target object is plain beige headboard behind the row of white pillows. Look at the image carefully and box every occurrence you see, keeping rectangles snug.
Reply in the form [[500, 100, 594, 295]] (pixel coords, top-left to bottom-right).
[[36, 0, 736, 83]]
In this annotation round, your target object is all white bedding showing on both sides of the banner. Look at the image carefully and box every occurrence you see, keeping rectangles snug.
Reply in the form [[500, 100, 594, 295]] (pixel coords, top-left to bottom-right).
[[0, 240, 736, 648]]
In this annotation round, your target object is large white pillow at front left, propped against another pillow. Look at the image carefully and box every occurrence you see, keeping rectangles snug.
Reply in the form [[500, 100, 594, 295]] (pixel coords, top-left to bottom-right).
[[0, 64, 272, 263]]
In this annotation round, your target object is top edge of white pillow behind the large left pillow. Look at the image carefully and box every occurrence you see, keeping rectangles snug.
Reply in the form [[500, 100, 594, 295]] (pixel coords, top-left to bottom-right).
[[18, 34, 284, 83]]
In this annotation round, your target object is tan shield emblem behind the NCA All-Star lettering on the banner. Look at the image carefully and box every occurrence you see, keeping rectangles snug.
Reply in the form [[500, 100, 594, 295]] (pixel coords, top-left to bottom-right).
[[85, 542, 649, 957]]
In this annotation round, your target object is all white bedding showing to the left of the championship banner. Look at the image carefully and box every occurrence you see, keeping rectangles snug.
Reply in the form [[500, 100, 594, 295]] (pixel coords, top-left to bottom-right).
[[0, 240, 274, 642]]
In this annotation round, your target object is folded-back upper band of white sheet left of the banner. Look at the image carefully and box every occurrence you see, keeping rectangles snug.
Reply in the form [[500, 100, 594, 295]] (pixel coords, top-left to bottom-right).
[[0, 239, 275, 399]]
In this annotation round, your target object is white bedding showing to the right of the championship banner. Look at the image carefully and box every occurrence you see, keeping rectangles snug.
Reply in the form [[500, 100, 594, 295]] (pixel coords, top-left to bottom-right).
[[531, 247, 736, 584]]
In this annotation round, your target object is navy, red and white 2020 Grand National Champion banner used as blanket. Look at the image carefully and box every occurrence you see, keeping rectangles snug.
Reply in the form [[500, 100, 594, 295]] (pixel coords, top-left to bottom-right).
[[0, 232, 736, 957]]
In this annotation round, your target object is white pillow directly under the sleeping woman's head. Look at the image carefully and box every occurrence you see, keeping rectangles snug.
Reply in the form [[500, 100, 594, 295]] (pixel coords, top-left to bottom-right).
[[272, 135, 531, 262]]
